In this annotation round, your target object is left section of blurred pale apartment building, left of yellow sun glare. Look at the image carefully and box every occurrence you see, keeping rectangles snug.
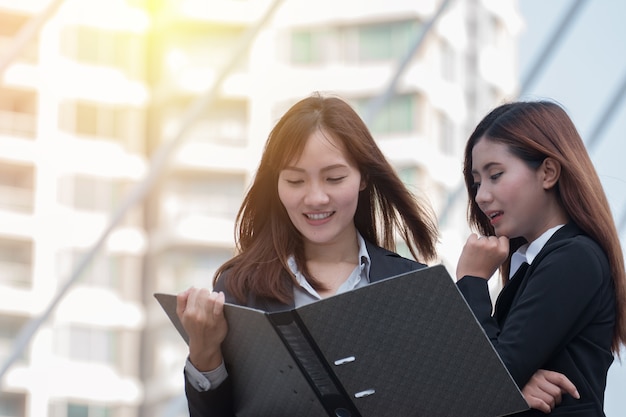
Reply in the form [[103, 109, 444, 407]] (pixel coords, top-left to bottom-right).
[[0, 1, 150, 417]]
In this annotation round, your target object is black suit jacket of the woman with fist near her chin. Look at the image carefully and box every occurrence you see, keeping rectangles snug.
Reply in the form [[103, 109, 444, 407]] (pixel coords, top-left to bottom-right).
[[458, 223, 615, 417]]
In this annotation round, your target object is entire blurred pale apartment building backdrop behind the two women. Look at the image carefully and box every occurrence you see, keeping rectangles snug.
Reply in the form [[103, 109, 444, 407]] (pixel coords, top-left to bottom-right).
[[0, 0, 521, 417]]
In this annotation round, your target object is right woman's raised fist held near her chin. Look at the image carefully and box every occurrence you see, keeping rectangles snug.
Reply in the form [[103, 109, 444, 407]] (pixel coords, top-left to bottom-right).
[[456, 233, 509, 280]]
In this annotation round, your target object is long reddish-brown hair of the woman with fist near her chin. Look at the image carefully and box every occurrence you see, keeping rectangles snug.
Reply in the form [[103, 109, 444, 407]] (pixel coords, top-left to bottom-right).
[[463, 101, 626, 352]]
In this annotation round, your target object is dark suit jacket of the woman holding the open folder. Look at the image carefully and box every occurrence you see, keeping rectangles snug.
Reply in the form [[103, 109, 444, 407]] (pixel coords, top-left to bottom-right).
[[185, 242, 426, 417]]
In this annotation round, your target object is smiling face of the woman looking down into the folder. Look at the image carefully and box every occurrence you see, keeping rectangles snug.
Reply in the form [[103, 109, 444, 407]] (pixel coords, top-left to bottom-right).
[[278, 130, 364, 250]]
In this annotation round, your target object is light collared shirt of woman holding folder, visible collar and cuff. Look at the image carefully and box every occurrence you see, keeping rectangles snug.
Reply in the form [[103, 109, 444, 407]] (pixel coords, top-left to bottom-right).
[[185, 231, 371, 391]]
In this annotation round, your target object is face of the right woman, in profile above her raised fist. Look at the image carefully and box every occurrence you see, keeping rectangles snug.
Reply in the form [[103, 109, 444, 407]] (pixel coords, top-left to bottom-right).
[[472, 137, 563, 242]]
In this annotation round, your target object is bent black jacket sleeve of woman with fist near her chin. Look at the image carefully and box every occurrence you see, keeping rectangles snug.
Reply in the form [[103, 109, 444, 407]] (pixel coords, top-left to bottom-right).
[[459, 238, 611, 387]]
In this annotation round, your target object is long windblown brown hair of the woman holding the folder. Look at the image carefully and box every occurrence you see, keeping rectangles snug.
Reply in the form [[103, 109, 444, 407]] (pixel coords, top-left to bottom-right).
[[214, 94, 438, 302]]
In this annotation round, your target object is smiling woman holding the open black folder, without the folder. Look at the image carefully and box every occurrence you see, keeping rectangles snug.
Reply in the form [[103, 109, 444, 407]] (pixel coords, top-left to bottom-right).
[[177, 95, 437, 417]]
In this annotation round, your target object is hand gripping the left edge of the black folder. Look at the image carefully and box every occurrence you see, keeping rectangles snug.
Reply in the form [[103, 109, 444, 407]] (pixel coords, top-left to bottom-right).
[[176, 287, 228, 371]]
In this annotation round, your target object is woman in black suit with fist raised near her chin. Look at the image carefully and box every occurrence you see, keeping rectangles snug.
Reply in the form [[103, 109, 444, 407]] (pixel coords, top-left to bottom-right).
[[457, 101, 626, 417]]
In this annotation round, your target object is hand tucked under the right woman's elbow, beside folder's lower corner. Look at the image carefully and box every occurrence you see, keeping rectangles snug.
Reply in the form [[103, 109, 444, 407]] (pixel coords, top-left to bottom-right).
[[522, 369, 580, 414]]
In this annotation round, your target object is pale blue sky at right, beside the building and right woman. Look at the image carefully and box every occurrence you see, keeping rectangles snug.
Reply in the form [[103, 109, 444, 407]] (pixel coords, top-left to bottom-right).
[[518, 0, 626, 417]]
